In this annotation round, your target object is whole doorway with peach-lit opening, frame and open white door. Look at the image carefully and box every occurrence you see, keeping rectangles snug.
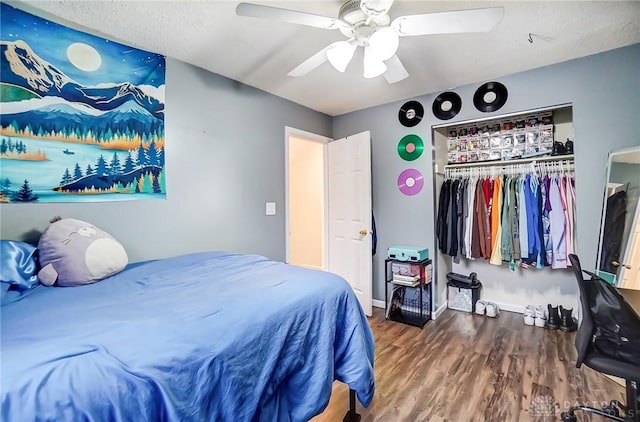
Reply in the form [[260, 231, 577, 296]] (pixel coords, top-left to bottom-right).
[[285, 127, 373, 316]]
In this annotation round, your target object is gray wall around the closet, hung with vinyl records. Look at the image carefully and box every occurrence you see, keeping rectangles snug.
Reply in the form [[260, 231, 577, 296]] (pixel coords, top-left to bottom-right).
[[333, 44, 640, 306]]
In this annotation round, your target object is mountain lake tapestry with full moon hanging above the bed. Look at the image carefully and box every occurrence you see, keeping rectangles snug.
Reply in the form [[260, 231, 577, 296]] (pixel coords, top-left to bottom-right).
[[0, 3, 166, 203]]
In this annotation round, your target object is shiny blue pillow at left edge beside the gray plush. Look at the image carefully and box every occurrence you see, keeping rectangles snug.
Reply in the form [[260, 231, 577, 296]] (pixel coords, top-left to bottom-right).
[[0, 240, 38, 290]]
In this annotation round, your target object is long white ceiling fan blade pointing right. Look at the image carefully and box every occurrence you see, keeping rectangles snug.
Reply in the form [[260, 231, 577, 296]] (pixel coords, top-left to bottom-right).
[[391, 7, 504, 37]]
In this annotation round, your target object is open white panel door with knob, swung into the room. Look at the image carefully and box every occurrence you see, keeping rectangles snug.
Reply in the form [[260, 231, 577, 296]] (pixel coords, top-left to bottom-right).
[[328, 132, 373, 316]]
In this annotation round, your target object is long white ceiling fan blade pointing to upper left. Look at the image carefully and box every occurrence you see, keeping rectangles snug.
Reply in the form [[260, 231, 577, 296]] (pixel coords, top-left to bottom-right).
[[236, 3, 349, 29]]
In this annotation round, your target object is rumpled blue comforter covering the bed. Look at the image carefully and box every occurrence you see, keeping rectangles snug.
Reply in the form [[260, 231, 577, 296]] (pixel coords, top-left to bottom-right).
[[0, 252, 374, 422]]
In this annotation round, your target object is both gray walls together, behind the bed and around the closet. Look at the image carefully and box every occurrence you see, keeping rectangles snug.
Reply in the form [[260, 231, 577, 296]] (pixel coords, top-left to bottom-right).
[[0, 45, 640, 314]]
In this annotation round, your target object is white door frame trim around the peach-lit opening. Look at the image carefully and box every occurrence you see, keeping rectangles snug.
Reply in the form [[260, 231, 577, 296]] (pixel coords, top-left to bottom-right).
[[284, 126, 333, 271]]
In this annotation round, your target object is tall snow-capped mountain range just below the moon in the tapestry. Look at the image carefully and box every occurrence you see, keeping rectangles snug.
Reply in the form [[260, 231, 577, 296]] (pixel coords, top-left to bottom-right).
[[0, 40, 164, 120]]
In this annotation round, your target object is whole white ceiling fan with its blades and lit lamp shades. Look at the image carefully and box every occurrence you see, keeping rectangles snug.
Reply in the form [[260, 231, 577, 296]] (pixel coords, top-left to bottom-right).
[[236, 0, 504, 84]]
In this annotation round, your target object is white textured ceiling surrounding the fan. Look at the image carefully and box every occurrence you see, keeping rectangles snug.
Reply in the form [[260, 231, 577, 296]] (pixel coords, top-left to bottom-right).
[[7, 0, 640, 116]]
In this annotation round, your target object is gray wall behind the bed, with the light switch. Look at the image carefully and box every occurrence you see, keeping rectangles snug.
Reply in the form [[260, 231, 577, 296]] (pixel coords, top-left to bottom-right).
[[0, 59, 331, 262]]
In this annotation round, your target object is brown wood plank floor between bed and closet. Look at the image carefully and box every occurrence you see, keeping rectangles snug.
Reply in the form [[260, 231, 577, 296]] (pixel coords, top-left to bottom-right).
[[312, 308, 624, 422]]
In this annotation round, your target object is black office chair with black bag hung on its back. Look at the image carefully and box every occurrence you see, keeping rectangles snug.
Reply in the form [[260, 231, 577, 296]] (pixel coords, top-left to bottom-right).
[[561, 254, 640, 422]]
